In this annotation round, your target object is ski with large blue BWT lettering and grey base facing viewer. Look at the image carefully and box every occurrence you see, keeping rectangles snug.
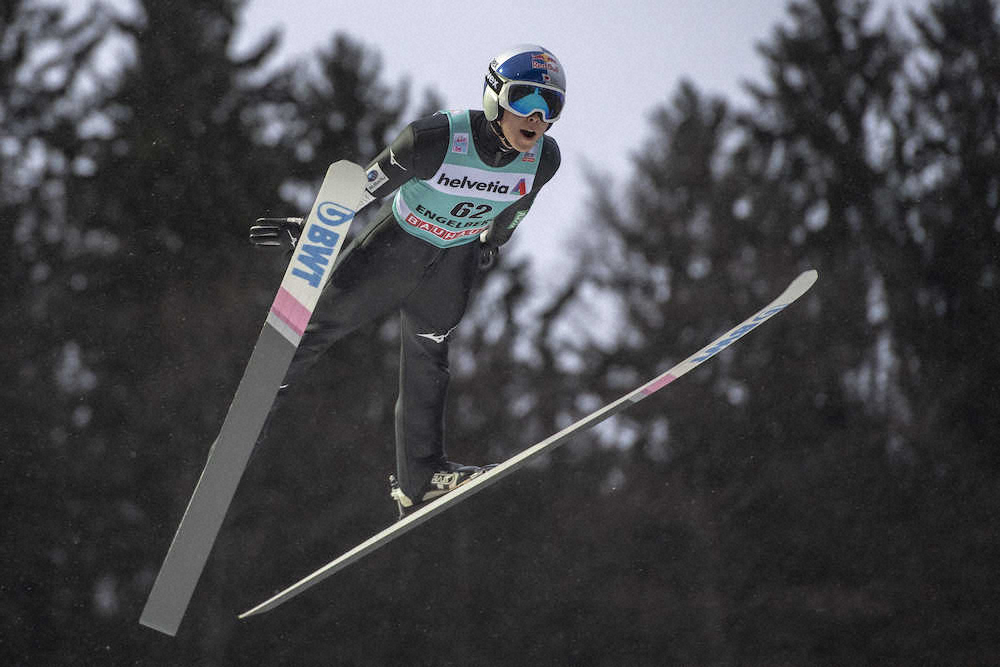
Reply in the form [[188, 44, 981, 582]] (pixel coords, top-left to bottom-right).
[[139, 160, 366, 635]]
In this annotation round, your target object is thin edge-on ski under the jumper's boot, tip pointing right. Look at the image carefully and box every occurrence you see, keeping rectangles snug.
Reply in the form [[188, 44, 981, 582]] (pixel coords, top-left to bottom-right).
[[239, 270, 818, 618]]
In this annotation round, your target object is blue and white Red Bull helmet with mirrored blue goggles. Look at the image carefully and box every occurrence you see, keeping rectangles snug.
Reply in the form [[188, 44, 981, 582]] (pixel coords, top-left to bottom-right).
[[483, 44, 566, 123]]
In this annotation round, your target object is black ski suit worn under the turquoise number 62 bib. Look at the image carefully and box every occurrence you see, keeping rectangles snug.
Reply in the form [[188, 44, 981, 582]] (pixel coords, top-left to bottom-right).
[[274, 111, 560, 498]]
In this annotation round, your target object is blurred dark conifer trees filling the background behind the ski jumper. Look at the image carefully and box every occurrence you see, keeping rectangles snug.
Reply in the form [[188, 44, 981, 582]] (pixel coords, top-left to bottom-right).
[[0, 0, 1000, 666]]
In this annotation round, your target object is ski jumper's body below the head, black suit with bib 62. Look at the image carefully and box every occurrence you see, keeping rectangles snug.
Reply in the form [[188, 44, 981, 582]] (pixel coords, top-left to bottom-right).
[[274, 111, 560, 498]]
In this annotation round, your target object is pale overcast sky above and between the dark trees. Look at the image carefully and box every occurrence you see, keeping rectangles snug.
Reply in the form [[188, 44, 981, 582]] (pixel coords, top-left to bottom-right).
[[97, 0, 927, 282]]
